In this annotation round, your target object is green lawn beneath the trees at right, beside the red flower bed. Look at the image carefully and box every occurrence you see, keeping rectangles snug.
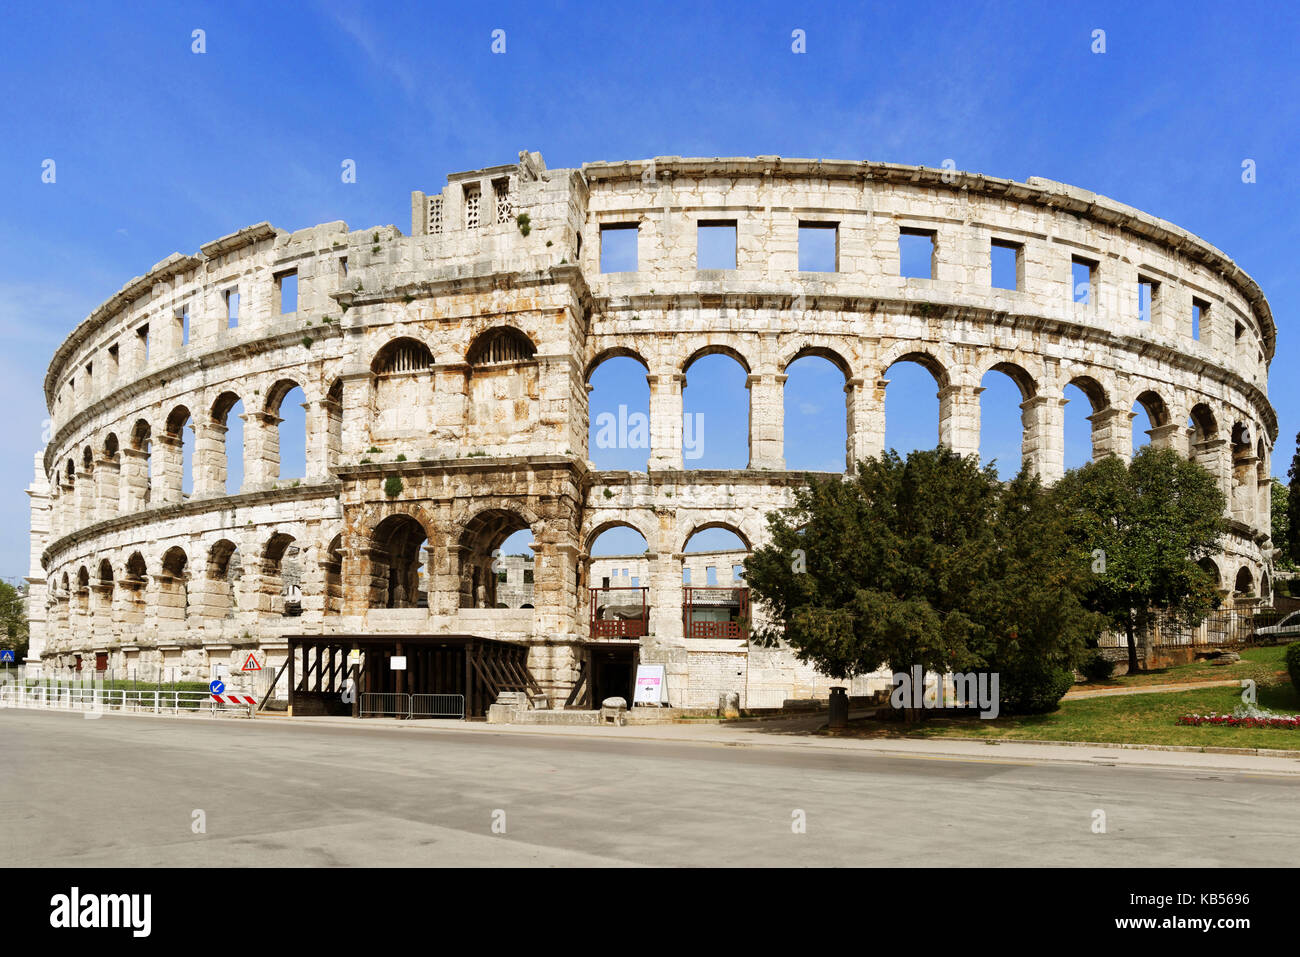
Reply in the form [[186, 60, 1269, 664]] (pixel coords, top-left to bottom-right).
[[826, 648, 1300, 750]]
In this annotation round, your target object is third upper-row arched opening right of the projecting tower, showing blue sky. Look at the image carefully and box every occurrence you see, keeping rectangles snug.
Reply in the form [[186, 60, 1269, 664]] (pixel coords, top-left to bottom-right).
[[783, 350, 852, 472]]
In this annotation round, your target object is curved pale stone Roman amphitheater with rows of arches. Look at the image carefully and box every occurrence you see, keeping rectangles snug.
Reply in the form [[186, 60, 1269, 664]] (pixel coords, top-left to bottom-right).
[[29, 152, 1278, 714]]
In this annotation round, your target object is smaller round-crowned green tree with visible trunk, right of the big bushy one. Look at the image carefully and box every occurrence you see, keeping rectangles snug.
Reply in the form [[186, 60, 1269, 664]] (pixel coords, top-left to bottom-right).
[[1052, 446, 1226, 674]]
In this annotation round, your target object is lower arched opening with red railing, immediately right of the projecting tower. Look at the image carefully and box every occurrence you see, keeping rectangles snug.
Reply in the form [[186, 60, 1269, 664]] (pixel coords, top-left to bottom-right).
[[585, 524, 651, 638]]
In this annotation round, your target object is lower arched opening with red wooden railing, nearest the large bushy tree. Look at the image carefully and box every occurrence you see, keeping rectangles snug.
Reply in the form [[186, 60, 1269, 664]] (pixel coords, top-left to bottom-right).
[[681, 523, 750, 638]]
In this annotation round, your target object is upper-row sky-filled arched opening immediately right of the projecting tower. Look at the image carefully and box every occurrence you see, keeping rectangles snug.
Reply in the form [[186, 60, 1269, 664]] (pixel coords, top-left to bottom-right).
[[586, 355, 650, 472]]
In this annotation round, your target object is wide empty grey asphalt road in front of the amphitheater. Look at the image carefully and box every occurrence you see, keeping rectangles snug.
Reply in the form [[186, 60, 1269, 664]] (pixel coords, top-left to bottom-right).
[[0, 709, 1300, 867]]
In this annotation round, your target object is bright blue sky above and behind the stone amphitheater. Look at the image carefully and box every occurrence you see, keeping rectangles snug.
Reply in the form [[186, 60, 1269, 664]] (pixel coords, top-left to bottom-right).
[[0, 3, 1300, 577]]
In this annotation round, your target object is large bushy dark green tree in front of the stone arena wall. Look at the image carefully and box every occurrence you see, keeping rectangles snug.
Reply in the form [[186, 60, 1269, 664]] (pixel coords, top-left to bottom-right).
[[745, 447, 1100, 703]]
